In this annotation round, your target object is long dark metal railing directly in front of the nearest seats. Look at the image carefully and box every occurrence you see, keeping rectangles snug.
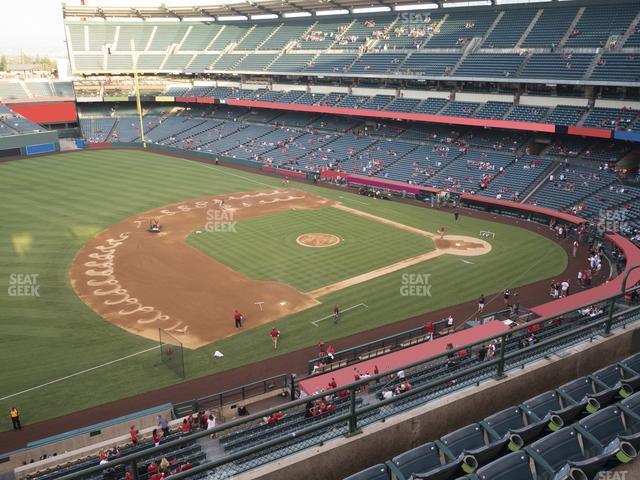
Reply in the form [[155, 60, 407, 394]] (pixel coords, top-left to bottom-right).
[[51, 286, 640, 480]]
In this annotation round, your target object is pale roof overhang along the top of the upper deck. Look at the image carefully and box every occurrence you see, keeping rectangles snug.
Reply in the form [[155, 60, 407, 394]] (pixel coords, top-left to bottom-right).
[[62, 0, 495, 20]]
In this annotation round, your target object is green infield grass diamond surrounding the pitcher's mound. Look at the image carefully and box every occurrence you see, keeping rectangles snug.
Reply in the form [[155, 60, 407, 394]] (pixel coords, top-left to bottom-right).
[[188, 207, 434, 292]]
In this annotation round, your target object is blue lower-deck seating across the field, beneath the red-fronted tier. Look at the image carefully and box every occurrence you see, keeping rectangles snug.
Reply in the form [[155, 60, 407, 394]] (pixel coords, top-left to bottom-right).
[[77, 106, 640, 231]]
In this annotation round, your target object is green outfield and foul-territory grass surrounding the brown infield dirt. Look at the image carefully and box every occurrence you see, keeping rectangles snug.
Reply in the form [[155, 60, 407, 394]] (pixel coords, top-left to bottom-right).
[[0, 150, 567, 430]]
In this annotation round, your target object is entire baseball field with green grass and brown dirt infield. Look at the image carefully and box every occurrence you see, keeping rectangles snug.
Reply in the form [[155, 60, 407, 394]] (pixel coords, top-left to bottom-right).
[[0, 150, 567, 430]]
